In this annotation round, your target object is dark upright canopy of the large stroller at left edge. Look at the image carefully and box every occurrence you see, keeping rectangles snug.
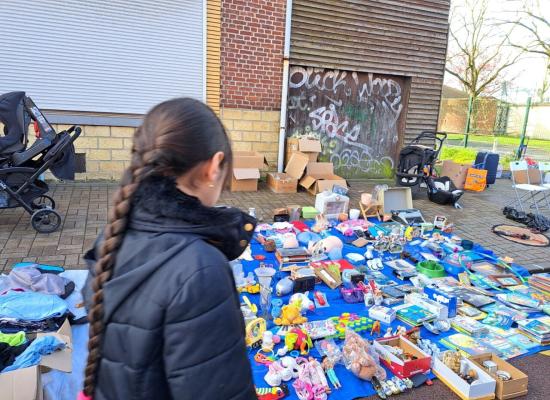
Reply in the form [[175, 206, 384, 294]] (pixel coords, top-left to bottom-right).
[[0, 92, 30, 153]]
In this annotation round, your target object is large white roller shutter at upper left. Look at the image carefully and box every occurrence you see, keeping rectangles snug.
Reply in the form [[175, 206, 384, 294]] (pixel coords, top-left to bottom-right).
[[0, 0, 206, 114]]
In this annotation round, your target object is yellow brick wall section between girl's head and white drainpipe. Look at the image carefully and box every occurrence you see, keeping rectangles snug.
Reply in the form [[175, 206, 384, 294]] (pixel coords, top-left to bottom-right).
[[220, 107, 280, 170]]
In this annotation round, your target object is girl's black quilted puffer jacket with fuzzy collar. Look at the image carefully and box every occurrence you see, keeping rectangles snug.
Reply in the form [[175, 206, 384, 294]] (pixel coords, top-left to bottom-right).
[[83, 177, 256, 400]]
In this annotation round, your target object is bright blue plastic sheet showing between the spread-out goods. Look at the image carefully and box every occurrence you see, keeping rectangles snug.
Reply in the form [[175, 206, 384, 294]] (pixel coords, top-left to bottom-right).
[[246, 223, 550, 400]]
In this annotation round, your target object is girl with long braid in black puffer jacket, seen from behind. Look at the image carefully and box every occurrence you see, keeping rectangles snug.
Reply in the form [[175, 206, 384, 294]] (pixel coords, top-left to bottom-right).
[[79, 99, 256, 400]]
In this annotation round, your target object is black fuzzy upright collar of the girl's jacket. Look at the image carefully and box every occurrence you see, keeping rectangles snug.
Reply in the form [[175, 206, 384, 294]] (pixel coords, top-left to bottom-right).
[[129, 176, 256, 260]]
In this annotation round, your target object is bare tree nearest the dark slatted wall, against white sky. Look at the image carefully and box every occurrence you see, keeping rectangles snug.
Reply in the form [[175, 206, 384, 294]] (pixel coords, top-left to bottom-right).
[[445, 0, 521, 100]]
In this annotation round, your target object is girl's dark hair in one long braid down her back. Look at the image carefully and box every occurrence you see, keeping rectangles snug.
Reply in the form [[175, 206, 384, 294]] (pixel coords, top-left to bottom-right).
[[84, 98, 232, 396]]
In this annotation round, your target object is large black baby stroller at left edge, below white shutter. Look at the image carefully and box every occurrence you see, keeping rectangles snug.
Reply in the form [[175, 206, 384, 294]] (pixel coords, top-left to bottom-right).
[[0, 92, 81, 233]]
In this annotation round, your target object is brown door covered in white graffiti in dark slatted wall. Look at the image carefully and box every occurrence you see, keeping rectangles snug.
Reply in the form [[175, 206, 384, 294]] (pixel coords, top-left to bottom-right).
[[287, 66, 409, 179]]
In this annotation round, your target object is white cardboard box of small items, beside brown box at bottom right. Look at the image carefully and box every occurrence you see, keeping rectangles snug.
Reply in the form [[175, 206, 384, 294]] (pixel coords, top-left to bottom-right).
[[432, 357, 497, 400]]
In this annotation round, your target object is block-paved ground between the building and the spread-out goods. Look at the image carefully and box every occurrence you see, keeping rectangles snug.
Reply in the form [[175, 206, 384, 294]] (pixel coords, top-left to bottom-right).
[[0, 180, 550, 271]]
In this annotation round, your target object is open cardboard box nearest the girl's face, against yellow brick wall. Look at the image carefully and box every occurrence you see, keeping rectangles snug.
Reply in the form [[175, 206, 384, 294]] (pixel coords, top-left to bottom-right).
[[231, 151, 267, 192]]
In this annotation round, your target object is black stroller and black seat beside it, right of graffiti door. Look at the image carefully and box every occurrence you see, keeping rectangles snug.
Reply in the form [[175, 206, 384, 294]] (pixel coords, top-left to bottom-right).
[[395, 131, 463, 208]]
